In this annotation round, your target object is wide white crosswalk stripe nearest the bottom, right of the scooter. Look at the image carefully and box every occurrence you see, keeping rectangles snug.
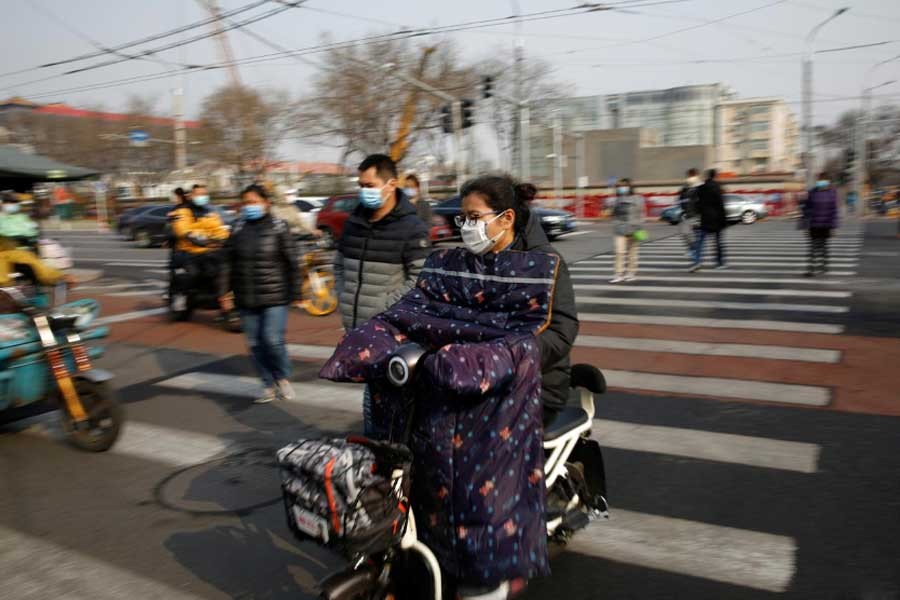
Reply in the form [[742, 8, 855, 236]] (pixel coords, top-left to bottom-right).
[[566, 507, 797, 592]]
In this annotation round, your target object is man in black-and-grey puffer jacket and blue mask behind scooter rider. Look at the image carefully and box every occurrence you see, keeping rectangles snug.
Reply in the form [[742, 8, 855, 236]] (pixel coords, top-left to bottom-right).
[[334, 154, 431, 438]]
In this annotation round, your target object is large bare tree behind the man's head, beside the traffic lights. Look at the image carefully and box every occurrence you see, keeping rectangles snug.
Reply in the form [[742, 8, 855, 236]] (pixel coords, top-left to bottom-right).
[[298, 40, 477, 169]]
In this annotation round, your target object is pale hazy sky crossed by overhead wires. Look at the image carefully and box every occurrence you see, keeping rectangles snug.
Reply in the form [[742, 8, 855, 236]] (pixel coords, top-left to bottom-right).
[[0, 0, 900, 160]]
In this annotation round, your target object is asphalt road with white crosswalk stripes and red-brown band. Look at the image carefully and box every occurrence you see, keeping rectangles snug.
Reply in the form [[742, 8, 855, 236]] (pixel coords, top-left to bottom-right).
[[0, 222, 900, 600]]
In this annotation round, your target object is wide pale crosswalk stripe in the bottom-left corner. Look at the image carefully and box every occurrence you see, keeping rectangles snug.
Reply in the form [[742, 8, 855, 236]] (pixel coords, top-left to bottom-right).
[[0, 525, 202, 600]]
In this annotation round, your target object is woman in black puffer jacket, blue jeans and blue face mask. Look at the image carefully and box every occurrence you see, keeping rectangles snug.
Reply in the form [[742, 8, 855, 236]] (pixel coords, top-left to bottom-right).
[[224, 185, 300, 404]]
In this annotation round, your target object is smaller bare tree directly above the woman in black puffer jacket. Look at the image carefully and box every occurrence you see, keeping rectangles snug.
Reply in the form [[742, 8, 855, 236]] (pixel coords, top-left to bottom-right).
[[198, 85, 297, 175]]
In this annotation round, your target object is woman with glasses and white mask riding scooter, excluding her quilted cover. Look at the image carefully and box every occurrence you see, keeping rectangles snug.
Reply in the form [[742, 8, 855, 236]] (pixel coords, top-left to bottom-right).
[[457, 175, 578, 424]]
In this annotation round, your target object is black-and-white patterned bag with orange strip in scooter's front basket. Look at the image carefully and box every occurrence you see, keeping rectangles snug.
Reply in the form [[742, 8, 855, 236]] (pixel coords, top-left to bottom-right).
[[277, 437, 412, 558]]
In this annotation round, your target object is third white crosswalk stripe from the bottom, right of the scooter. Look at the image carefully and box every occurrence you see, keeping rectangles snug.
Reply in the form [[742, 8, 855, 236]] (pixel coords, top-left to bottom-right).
[[603, 369, 831, 406]]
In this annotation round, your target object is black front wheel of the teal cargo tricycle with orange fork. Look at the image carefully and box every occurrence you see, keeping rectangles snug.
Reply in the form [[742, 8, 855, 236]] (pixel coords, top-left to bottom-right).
[[61, 381, 125, 452]]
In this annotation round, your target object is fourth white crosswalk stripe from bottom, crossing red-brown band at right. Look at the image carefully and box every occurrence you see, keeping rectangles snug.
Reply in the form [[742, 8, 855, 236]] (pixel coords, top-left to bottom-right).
[[575, 335, 841, 364]]
